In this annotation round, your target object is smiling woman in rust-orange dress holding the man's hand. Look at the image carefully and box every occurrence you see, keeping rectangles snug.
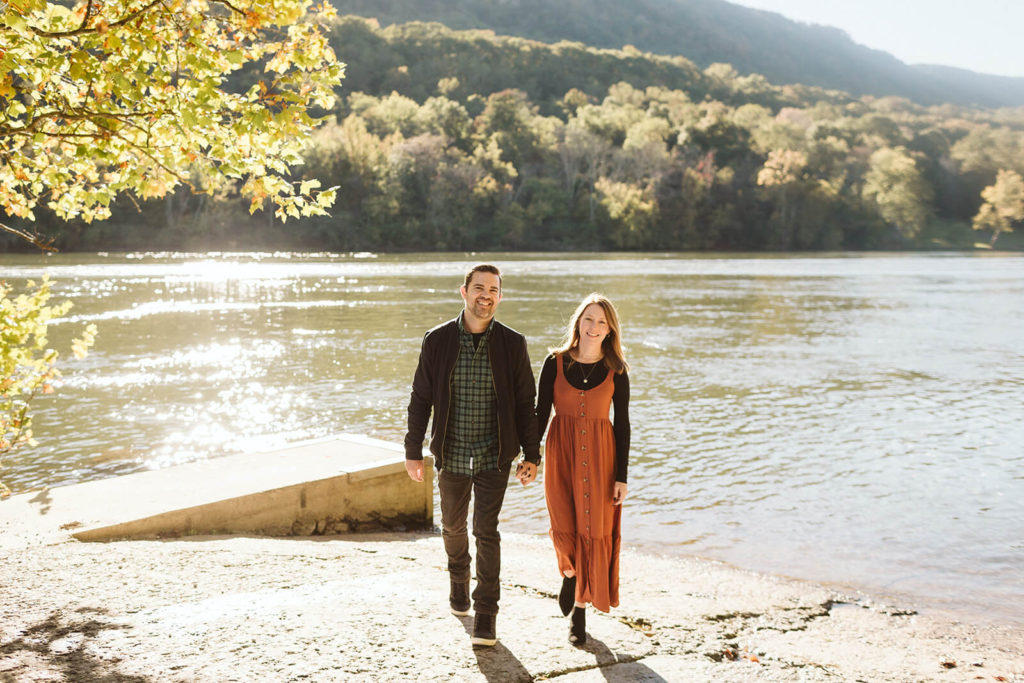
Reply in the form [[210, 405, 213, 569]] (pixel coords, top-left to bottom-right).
[[537, 294, 630, 645]]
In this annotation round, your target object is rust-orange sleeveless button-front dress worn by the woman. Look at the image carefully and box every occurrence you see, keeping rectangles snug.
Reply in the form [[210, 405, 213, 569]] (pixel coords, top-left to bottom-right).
[[544, 356, 623, 612]]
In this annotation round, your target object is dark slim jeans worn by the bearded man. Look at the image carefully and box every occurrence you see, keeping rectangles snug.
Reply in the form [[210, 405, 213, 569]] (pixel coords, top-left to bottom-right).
[[437, 470, 509, 614]]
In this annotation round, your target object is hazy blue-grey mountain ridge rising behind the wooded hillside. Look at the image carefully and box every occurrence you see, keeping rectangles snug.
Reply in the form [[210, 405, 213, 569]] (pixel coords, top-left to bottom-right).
[[334, 0, 1024, 108]]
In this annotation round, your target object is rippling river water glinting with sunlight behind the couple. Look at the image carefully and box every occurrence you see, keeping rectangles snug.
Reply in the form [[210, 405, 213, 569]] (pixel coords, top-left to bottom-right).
[[0, 254, 1024, 622]]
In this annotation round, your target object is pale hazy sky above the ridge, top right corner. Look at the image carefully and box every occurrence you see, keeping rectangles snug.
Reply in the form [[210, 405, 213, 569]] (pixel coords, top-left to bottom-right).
[[729, 0, 1024, 76]]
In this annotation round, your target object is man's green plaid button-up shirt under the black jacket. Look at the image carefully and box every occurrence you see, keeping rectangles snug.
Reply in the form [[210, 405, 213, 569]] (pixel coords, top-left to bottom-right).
[[444, 315, 498, 476]]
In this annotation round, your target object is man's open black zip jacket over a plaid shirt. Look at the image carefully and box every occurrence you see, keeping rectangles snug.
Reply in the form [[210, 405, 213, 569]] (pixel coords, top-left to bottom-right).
[[406, 317, 541, 471]]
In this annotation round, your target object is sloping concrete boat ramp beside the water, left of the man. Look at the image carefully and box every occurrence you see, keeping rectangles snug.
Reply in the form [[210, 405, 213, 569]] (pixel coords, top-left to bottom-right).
[[0, 434, 433, 541]]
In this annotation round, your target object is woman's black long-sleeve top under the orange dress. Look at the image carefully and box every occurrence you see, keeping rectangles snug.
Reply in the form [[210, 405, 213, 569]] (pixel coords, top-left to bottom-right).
[[537, 353, 630, 483]]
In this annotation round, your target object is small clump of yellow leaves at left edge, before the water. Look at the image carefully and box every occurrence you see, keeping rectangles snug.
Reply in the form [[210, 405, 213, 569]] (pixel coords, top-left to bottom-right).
[[0, 276, 96, 498]]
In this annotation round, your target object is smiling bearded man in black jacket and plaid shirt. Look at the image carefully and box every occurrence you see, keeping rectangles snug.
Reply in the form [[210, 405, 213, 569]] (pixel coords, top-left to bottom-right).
[[406, 264, 541, 645]]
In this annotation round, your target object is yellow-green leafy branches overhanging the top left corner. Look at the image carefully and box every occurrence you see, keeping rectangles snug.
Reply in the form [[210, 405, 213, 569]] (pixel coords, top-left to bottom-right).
[[0, 0, 344, 245]]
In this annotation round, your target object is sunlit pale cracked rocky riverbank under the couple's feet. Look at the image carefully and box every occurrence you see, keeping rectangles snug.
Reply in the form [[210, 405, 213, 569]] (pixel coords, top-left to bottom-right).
[[0, 530, 1024, 683]]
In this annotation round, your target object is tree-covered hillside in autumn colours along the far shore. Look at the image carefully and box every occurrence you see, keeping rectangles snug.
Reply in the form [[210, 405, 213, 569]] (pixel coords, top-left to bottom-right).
[[7, 16, 1024, 250]]
